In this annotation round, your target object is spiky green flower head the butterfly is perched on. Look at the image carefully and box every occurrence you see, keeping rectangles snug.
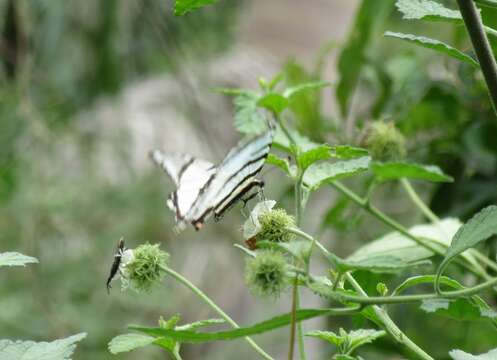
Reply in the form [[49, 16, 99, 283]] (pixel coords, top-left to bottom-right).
[[257, 209, 295, 242]]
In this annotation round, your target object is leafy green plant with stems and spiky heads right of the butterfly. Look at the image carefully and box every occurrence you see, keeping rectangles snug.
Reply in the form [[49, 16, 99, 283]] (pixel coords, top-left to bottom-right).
[[103, 0, 497, 359]]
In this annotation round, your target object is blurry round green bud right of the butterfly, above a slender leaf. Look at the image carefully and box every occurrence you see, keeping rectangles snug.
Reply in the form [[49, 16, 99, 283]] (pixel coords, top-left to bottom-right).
[[363, 121, 407, 161]]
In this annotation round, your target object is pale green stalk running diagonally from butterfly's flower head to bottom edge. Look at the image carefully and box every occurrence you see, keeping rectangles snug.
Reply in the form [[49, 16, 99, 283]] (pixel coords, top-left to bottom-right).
[[288, 228, 436, 360]]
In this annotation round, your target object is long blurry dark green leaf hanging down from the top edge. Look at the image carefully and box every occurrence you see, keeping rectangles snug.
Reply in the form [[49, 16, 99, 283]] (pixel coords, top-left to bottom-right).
[[336, 0, 394, 115]]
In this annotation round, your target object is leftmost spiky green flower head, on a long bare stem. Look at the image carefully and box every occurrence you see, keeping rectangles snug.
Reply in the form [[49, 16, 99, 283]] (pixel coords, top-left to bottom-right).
[[123, 243, 169, 292]]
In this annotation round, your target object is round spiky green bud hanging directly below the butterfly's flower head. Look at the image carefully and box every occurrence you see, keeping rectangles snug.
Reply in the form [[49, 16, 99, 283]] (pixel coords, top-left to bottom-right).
[[245, 250, 290, 298]]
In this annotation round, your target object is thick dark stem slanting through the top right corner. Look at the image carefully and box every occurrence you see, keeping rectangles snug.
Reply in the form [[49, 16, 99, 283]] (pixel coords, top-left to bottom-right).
[[457, 0, 497, 112]]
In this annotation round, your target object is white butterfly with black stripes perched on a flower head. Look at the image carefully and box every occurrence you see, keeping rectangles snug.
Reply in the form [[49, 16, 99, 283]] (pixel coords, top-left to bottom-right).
[[150, 127, 274, 230]]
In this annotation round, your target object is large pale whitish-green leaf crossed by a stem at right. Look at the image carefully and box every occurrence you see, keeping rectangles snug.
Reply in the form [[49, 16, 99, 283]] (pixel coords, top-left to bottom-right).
[[347, 218, 460, 263]]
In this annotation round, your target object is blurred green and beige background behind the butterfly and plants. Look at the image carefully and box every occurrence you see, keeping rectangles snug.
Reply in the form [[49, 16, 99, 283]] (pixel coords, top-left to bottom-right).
[[0, 0, 497, 359]]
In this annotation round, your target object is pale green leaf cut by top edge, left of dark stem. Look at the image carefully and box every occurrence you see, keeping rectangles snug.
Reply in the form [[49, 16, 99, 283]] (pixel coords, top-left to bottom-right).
[[395, 0, 462, 22]]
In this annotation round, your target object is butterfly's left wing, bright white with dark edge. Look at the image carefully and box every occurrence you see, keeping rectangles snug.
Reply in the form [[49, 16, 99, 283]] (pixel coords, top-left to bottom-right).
[[151, 150, 216, 225]]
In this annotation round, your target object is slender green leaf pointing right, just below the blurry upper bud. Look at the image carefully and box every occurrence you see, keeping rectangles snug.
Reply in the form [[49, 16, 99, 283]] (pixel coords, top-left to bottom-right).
[[371, 161, 454, 182]]
